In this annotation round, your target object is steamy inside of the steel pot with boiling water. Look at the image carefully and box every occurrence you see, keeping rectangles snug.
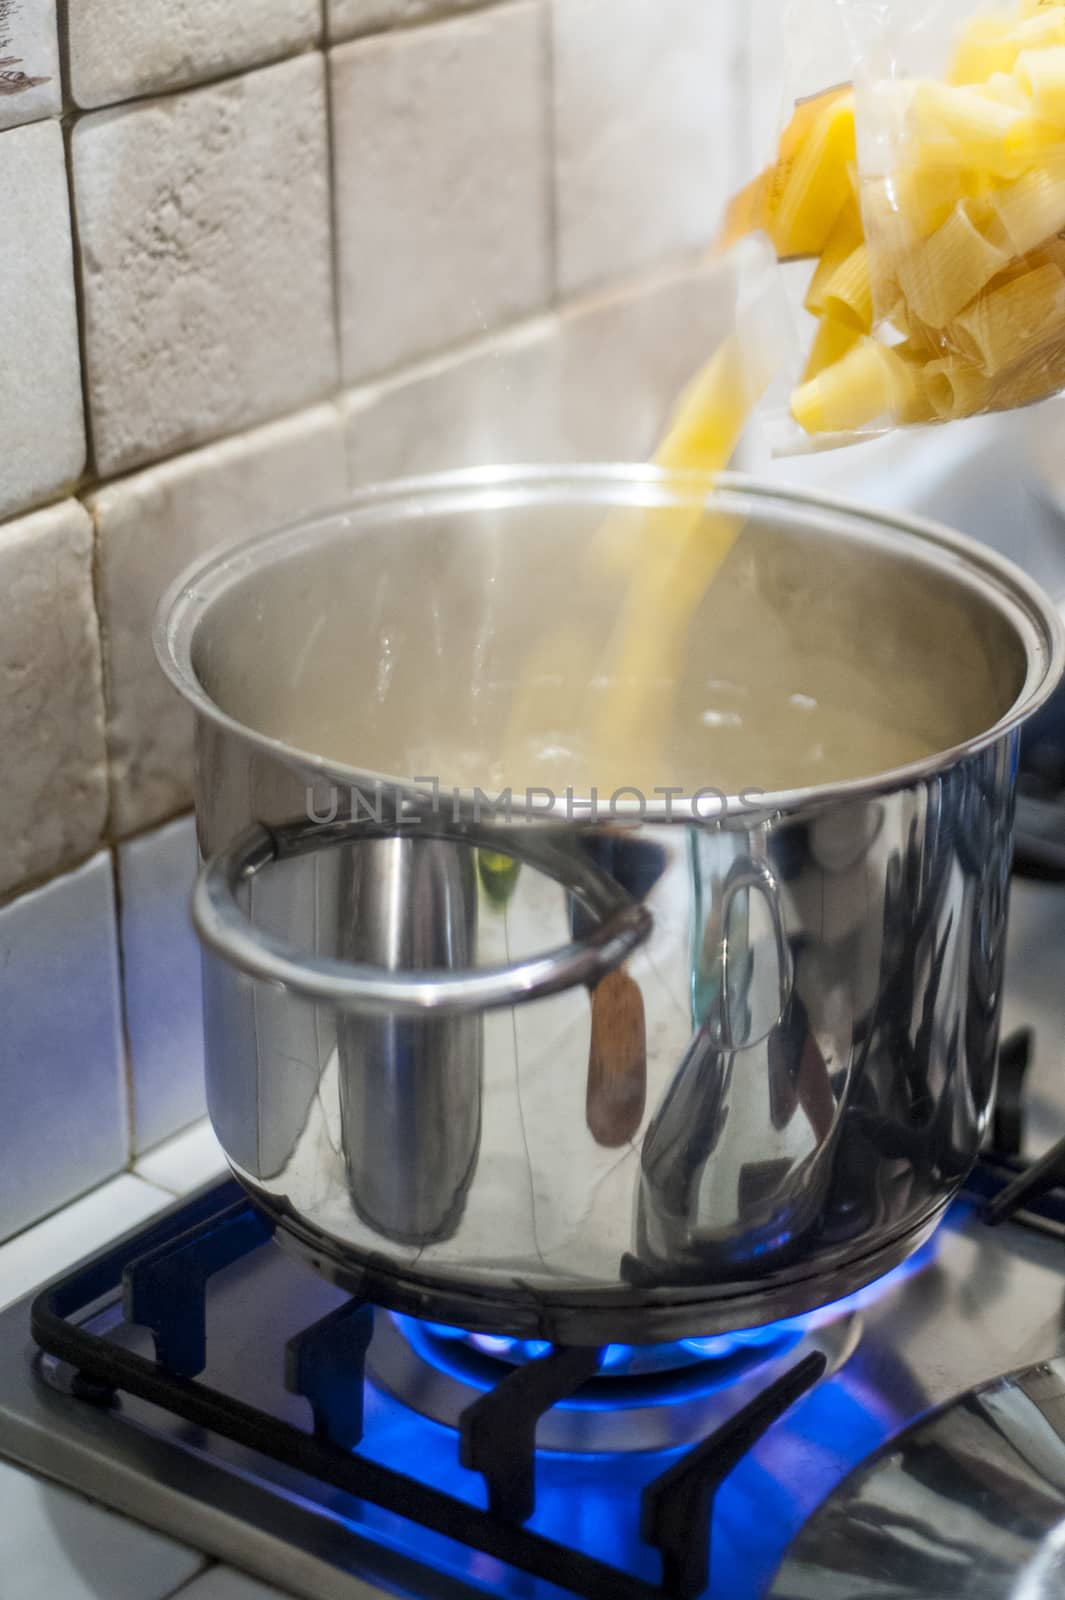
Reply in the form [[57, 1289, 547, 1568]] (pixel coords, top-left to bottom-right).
[[197, 496, 1023, 795]]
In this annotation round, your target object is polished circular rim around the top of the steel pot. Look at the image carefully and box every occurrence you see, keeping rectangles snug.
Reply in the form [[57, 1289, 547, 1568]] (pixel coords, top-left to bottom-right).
[[152, 462, 1065, 824]]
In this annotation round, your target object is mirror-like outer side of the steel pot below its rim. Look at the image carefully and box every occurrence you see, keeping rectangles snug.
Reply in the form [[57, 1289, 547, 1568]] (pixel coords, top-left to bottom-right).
[[195, 730, 1015, 1342]]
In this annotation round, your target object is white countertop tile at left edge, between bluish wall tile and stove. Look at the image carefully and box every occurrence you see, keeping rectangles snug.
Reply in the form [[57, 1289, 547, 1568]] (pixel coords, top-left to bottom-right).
[[0, 1173, 174, 1305]]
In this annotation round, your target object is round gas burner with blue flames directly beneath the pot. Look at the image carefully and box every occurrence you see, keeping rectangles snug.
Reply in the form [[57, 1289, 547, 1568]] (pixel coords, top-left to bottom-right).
[[366, 1302, 860, 1454]]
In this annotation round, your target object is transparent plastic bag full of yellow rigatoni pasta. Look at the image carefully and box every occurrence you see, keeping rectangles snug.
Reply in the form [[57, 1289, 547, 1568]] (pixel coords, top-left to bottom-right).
[[724, 0, 1065, 450]]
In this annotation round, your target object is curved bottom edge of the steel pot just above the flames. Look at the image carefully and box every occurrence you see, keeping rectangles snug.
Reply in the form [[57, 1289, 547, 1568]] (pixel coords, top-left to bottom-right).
[[235, 1171, 953, 1346]]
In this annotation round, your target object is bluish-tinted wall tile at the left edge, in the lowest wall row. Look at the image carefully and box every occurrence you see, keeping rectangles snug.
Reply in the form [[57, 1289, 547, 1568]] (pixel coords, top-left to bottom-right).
[[0, 853, 126, 1238]]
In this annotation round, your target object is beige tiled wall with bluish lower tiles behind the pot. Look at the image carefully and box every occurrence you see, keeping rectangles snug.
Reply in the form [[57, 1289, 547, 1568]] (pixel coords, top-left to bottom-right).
[[0, 0, 745, 1238]]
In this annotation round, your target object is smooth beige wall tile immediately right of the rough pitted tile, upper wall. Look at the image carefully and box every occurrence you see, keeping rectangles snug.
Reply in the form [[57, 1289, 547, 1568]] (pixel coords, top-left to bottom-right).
[[331, 0, 550, 382]]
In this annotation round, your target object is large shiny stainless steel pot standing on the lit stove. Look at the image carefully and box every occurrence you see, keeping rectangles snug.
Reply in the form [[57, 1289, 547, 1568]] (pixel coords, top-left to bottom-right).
[[157, 467, 1065, 1344]]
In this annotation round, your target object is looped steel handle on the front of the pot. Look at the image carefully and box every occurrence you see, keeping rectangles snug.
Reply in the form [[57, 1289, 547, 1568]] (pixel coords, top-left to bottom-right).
[[192, 821, 654, 1019]]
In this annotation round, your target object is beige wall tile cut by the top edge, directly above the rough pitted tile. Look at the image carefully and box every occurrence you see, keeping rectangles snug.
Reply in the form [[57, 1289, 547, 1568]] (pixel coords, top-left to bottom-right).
[[67, 0, 321, 107]]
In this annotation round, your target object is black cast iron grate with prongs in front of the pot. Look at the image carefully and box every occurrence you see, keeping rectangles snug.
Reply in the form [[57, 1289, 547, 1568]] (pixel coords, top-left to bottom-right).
[[32, 1181, 828, 1600]]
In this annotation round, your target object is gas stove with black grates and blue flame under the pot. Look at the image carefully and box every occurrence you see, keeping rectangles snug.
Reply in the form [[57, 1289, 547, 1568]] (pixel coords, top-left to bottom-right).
[[0, 1011, 1065, 1600]]
